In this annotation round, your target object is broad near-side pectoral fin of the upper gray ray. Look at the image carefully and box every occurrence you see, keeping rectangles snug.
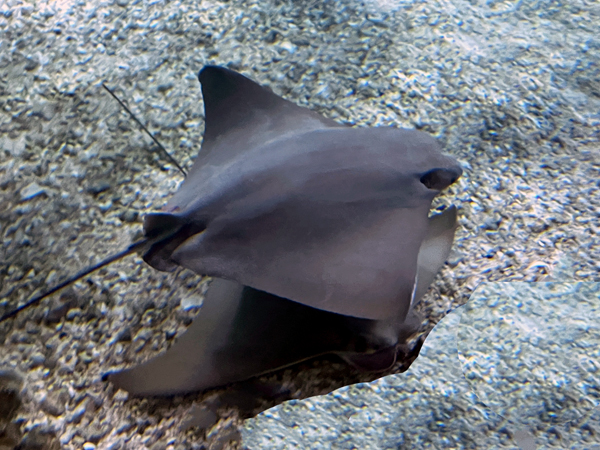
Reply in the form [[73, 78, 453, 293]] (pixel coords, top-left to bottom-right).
[[171, 205, 428, 320]]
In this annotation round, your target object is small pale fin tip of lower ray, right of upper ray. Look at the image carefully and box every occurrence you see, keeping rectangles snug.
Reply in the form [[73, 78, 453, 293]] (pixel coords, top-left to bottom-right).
[[413, 206, 457, 305]]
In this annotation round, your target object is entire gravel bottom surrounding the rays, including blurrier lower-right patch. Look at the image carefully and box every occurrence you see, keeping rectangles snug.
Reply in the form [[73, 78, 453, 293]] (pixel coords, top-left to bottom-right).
[[0, 0, 600, 450]]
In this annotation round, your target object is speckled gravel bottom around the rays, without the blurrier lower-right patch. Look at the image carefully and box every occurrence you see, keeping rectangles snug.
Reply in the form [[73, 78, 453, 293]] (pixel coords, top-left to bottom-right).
[[0, 0, 600, 450]]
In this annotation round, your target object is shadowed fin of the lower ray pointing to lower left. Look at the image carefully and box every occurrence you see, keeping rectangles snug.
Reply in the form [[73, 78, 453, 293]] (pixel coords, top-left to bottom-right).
[[107, 279, 369, 395]]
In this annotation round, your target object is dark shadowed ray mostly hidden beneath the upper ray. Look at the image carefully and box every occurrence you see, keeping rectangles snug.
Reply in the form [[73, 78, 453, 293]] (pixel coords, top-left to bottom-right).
[[109, 207, 456, 395]]
